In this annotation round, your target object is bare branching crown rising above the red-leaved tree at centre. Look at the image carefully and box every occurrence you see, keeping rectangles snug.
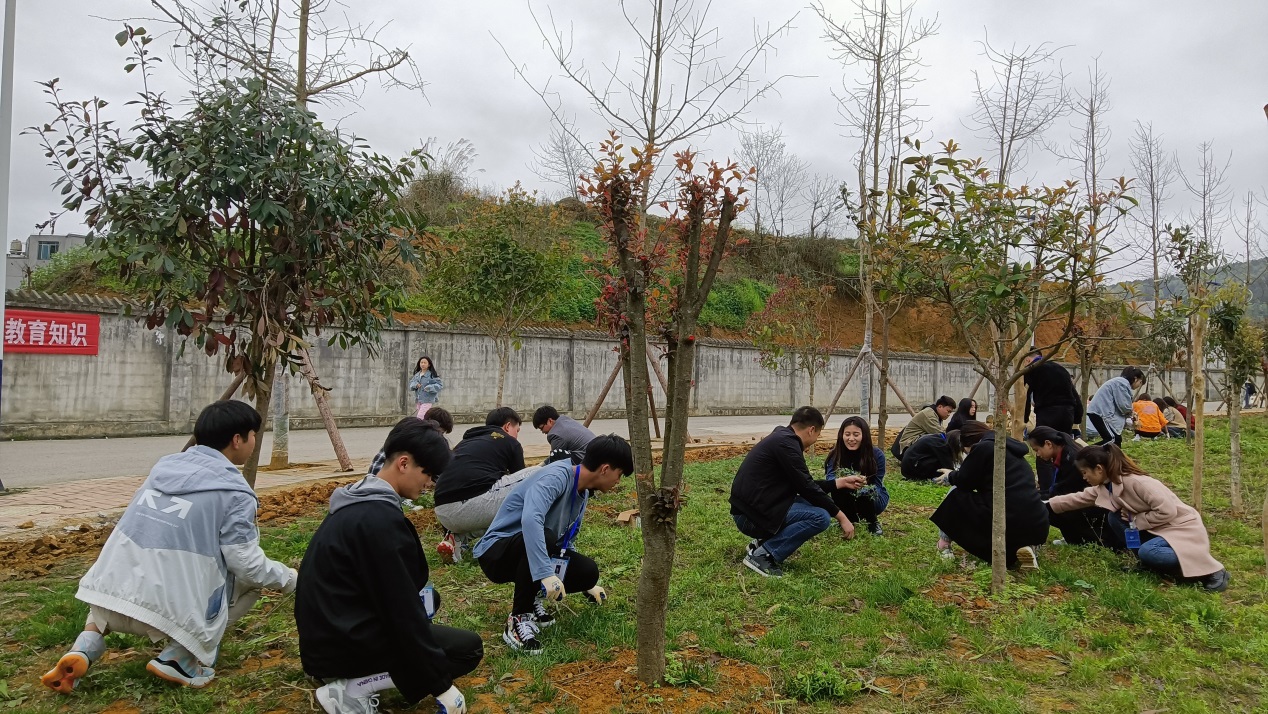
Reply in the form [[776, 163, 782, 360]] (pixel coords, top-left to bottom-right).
[[495, 0, 796, 214]]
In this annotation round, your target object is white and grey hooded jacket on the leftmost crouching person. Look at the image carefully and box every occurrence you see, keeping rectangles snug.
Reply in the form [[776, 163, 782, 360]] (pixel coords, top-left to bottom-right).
[[75, 446, 294, 666]]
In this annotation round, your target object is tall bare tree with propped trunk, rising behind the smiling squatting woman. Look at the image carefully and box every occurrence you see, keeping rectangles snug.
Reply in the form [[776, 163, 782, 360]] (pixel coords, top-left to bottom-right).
[[812, 0, 937, 415]]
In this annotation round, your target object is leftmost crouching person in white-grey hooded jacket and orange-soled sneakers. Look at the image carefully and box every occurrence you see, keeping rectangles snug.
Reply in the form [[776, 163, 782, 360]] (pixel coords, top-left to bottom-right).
[[41, 401, 298, 694]]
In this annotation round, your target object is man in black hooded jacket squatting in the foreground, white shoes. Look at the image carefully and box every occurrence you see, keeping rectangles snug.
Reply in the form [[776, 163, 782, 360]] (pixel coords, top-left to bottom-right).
[[295, 417, 484, 714]]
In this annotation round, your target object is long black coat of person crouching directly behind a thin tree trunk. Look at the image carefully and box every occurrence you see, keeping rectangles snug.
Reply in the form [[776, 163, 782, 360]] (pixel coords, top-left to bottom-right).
[[929, 434, 1049, 563]]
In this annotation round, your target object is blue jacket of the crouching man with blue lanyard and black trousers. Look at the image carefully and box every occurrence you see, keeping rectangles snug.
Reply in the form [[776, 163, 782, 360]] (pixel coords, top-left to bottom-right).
[[472, 460, 590, 580]]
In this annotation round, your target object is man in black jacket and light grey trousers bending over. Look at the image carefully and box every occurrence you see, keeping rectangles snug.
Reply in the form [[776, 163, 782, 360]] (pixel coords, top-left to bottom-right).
[[436, 407, 536, 562]]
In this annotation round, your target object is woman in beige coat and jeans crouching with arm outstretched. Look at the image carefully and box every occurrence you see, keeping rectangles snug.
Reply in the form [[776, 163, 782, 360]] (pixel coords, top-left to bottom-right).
[[1047, 444, 1229, 592]]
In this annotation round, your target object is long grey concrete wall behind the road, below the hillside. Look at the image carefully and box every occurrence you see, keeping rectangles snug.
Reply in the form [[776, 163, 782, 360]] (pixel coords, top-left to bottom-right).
[[0, 292, 1217, 439]]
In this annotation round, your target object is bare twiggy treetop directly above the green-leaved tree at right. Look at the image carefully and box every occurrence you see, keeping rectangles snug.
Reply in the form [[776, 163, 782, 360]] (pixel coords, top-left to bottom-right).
[[970, 37, 1070, 184]]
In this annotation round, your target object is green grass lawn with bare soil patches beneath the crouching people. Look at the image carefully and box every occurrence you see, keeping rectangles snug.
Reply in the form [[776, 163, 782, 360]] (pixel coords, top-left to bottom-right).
[[0, 417, 1268, 714]]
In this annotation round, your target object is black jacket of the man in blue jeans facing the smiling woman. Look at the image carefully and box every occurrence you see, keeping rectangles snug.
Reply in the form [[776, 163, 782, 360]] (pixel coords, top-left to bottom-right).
[[730, 426, 841, 538]]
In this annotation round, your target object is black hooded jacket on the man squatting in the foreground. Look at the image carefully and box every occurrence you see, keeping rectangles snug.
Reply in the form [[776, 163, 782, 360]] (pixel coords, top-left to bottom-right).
[[295, 476, 464, 704]]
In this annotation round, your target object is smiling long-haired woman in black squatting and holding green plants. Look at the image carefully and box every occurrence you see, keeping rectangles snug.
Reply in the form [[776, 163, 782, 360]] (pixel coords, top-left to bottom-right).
[[819, 416, 889, 535]]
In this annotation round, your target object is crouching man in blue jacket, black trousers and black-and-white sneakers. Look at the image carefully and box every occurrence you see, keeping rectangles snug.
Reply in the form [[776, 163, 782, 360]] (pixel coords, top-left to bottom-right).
[[472, 434, 634, 654]]
